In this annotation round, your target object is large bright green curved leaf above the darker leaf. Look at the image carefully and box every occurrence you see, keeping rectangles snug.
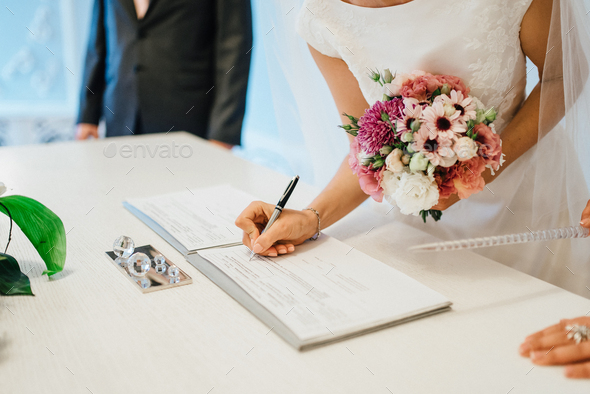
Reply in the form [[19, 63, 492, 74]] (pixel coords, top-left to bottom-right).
[[0, 196, 66, 276]]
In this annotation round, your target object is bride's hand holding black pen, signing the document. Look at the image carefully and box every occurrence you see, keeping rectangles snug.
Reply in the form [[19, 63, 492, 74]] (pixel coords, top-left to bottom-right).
[[236, 201, 317, 257]]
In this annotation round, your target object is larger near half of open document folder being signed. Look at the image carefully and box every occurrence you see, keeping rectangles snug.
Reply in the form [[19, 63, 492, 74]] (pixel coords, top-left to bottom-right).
[[195, 236, 451, 349]]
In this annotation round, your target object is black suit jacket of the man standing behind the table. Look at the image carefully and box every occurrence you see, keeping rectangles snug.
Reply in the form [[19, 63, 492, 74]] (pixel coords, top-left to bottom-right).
[[78, 0, 252, 145]]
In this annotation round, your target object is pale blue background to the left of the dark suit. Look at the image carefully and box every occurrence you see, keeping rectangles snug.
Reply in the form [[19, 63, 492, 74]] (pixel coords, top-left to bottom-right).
[[0, 0, 91, 145]]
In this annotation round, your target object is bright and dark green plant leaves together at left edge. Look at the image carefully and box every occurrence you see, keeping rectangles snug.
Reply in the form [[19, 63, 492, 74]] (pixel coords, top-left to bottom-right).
[[0, 192, 66, 295]]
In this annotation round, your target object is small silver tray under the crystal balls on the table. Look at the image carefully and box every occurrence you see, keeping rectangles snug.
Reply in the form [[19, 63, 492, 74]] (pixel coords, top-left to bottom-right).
[[105, 245, 193, 293]]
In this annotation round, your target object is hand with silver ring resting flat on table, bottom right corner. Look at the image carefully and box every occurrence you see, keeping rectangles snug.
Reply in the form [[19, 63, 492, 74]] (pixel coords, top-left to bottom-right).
[[519, 317, 590, 378]]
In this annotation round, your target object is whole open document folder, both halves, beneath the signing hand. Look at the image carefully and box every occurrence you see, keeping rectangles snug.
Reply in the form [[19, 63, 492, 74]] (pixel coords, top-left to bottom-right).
[[126, 186, 451, 349]]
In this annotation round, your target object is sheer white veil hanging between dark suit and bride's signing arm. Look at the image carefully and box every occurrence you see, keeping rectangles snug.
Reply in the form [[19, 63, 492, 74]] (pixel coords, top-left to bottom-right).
[[260, 0, 348, 188]]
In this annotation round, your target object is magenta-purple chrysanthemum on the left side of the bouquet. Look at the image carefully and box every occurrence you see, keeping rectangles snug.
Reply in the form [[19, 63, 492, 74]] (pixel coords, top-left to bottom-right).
[[356, 98, 404, 154]]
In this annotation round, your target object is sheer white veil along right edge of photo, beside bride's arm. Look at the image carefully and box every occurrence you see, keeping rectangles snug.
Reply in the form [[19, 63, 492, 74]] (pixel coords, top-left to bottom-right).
[[530, 0, 590, 296]]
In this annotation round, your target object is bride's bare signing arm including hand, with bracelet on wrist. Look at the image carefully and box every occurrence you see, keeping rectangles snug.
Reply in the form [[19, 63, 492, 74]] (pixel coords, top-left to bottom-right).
[[236, 46, 369, 256]]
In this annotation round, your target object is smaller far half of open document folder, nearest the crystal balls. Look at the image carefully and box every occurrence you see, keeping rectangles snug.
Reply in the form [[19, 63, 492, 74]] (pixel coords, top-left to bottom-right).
[[123, 185, 256, 255]]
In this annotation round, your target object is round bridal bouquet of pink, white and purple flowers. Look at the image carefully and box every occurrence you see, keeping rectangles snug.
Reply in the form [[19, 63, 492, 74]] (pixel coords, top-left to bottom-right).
[[340, 69, 504, 222]]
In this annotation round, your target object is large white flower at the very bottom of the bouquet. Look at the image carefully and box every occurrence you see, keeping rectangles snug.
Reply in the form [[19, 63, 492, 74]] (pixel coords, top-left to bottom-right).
[[394, 172, 439, 216]]
